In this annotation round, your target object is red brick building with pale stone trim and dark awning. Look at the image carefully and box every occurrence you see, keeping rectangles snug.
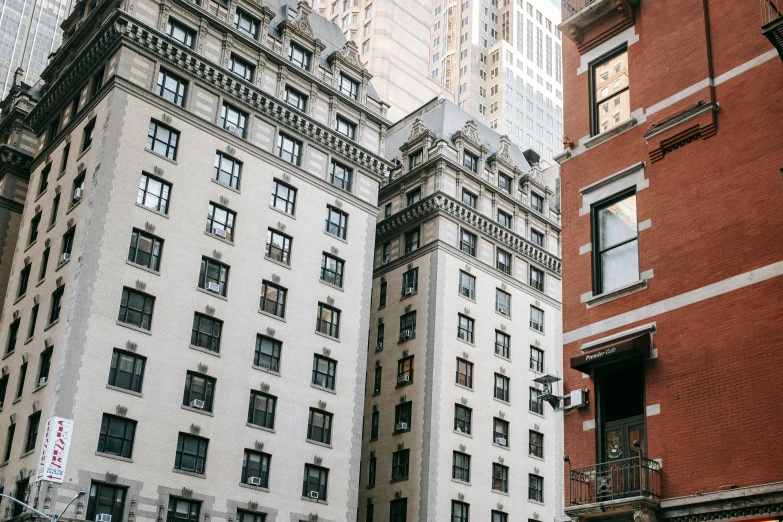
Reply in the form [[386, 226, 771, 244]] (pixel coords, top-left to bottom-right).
[[556, 0, 783, 522]]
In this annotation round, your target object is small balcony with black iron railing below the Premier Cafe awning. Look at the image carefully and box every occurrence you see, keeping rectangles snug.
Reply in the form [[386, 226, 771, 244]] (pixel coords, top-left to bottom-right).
[[566, 456, 661, 510]]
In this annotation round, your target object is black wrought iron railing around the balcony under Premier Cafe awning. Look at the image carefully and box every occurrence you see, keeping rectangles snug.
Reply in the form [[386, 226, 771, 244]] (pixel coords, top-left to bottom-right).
[[569, 456, 661, 506]]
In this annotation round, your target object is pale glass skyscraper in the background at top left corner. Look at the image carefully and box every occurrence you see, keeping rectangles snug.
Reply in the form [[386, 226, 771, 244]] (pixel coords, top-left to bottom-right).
[[0, 0, 71, 97]]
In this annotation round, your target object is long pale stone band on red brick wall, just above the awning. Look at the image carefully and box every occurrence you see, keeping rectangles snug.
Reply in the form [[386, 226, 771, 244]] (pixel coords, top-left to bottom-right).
[[563, 261, 783, 344]]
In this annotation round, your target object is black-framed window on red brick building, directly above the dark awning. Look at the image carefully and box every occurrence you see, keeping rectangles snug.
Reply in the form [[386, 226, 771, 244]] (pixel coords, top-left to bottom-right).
[[593, 192, 639, 294]]
